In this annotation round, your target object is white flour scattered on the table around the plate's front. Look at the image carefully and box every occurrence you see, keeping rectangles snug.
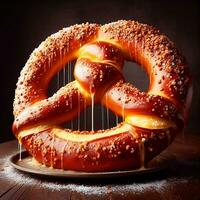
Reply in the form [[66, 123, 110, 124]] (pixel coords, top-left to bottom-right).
[[0, 157, 188, 196]]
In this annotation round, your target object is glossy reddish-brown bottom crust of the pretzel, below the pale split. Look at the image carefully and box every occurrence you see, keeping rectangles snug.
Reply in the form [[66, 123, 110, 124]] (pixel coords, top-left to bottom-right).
[[22, 124, 177, 172]]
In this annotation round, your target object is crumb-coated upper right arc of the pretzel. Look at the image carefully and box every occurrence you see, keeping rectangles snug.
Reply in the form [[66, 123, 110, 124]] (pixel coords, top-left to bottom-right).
[[99, 21, 191, 106]]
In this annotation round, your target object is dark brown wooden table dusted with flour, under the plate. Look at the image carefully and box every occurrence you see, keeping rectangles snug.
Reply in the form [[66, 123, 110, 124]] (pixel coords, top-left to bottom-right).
[[0, 134, 200, 200]]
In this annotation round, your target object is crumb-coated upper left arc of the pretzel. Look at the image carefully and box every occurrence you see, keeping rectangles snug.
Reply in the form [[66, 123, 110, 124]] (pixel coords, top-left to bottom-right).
[[14, 23, 99, 116]]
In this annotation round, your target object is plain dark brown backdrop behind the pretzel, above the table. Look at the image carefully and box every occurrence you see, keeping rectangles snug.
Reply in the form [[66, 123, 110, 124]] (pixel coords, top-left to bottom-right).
[[0, 0, 200, 142]]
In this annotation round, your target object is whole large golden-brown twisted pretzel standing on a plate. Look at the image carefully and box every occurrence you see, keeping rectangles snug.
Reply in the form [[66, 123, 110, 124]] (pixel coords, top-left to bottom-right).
[[13, 21, 192, 172]]
